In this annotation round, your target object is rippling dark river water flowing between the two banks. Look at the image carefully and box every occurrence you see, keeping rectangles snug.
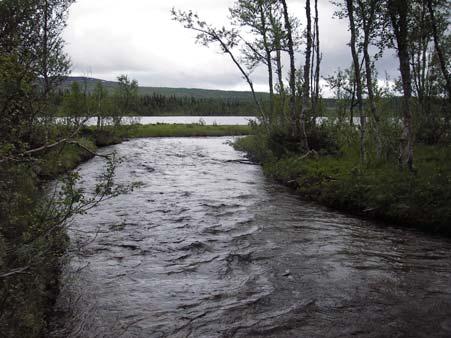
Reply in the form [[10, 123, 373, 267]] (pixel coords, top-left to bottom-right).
[[53, 138, 451, 338]]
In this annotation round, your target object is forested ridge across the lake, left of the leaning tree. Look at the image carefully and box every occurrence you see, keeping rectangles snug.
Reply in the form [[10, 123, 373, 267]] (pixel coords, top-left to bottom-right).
[[54, 77, 267, 116]]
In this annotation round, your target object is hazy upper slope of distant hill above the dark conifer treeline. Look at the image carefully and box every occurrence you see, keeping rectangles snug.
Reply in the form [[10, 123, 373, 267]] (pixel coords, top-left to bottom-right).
[[61, 76, 269, 101]]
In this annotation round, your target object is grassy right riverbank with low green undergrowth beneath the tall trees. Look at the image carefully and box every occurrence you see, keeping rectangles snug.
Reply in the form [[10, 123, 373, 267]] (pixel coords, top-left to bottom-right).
[[235, 136, 451, 236]]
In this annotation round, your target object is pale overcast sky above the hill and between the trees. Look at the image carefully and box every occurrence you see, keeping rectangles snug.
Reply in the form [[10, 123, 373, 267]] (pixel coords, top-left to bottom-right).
[[64, 0, 397, 91]]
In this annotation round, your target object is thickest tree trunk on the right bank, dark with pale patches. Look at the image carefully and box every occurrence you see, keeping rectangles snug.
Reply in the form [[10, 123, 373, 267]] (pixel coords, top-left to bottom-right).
[[388, 0, 413, 170]]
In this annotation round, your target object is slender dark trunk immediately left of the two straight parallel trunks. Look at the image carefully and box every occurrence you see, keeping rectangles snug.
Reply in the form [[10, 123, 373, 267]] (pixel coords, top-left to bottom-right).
[[280, 0, 299, 137]]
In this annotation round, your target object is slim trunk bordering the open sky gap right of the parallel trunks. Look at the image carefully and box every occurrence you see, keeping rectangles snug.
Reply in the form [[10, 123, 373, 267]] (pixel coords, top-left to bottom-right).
[[346, 0, 366, 163]]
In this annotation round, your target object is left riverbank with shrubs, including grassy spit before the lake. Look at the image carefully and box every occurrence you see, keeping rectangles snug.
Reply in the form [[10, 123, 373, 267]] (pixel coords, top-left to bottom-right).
[[0, 124, 251, 338]]
